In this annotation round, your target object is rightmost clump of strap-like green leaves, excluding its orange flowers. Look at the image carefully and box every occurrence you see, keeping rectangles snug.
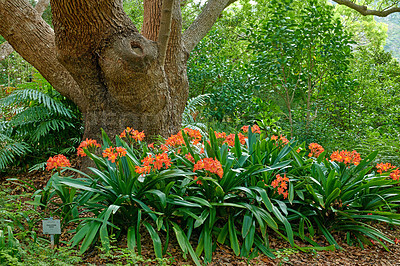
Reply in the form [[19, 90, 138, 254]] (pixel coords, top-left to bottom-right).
[[292, 152, 400, 249]]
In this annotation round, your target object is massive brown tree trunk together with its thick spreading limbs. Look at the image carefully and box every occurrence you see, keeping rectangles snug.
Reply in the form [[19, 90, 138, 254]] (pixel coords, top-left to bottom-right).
[[0, 0, 238, 139]]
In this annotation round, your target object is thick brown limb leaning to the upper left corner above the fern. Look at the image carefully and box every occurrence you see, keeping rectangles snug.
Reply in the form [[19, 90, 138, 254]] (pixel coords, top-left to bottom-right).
[[0, 0, 85, 111]]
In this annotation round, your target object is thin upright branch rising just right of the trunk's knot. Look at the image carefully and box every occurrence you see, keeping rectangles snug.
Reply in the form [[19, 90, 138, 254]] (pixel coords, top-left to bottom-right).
[[157, 0, 174, 65]]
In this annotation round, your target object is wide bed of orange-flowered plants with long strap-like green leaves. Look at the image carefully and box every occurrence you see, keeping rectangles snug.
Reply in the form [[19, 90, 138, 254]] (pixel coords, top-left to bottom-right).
[[45, 125, 400, 264]]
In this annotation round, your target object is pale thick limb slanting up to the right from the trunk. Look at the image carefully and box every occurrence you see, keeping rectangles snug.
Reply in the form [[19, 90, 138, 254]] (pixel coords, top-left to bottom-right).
[[183, 0, 236, 52]]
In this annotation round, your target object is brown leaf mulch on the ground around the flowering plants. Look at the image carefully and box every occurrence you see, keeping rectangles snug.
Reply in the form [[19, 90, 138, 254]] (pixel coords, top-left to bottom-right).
[[0, 158, 400, 266]]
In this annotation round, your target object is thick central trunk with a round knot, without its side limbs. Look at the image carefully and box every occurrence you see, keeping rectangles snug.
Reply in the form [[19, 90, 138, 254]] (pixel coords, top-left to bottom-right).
[[51, 0, 188, 137]]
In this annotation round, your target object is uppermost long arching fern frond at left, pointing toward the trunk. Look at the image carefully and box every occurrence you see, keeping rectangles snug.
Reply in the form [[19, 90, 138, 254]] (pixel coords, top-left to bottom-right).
[[0, 89, 73, 118]]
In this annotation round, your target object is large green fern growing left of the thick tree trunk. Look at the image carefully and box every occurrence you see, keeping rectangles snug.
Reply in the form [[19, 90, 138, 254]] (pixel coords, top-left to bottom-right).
[[0, 74, 82, 170]]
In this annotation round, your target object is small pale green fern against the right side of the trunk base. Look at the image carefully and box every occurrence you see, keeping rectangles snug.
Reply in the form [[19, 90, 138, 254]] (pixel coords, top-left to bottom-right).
[[182, 94, 210, 136]]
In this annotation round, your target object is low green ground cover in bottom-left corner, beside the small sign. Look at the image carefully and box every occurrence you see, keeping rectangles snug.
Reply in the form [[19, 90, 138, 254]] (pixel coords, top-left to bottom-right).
[[0, 187, 81, 266]]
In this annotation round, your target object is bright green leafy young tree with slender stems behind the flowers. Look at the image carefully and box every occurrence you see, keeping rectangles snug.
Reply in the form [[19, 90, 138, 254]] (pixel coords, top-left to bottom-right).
[[247, 0, 351, 134]]
